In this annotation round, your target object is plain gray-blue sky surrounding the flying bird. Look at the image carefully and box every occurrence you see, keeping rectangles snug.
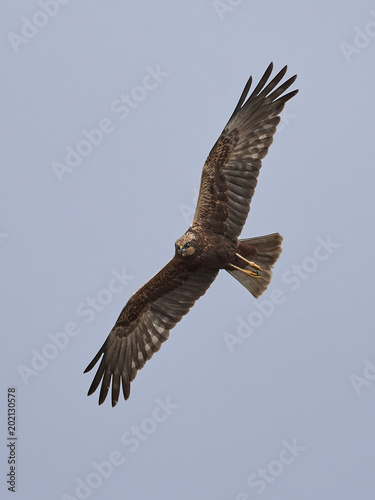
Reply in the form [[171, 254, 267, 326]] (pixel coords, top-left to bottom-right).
[[0, 0, 375, 500]]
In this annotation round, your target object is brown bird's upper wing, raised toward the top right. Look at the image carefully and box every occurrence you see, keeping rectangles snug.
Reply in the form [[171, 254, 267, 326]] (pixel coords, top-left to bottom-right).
[[192, 63, 298, 240]]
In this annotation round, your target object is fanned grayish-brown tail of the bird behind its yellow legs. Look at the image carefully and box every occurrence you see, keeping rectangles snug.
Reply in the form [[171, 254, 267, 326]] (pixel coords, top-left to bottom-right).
[[226, 233, 283, 298]]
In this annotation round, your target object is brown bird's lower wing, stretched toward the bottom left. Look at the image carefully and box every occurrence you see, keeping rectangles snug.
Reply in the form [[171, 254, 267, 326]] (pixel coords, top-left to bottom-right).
[[85, 257, 218, 406]]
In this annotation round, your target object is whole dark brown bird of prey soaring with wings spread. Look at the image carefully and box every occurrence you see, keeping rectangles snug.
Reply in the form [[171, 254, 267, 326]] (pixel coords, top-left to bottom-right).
[[85, 63, 298, 406]]
